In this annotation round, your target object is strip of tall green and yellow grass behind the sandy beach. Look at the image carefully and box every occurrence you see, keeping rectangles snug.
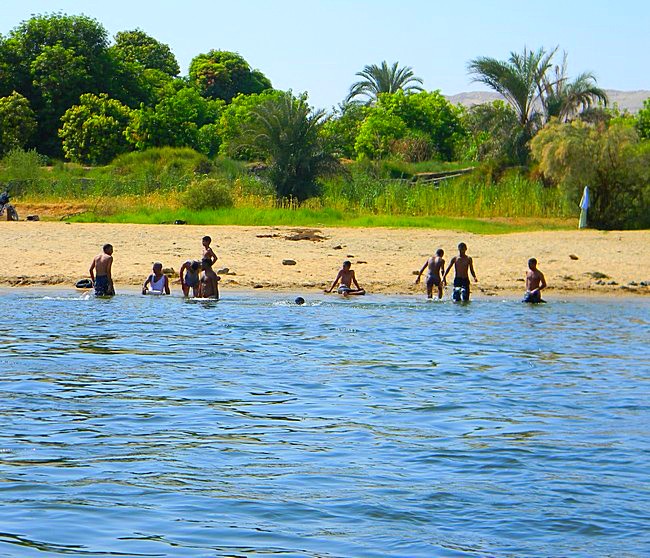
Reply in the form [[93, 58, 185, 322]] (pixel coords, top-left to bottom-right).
[[0, 148, 576, 227]]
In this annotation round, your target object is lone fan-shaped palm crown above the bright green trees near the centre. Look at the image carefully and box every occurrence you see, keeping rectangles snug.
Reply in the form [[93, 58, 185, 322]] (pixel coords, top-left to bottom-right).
[[346, 60, 424, 103]]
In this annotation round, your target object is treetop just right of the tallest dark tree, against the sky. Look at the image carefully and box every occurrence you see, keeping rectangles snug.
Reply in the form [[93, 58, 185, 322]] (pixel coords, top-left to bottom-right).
[[111, 29, 180, 77]]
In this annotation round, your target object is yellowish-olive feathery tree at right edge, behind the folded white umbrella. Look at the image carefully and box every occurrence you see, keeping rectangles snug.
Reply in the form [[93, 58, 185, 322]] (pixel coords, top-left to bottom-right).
[[531, 121, 650, 229]]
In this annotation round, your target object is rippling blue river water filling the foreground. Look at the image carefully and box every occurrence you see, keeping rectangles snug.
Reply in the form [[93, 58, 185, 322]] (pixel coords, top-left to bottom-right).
[[0, 290, 650, 558]]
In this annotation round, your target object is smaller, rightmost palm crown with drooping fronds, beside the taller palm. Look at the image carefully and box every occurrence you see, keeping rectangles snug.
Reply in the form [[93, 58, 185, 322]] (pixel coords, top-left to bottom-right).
[[543, 52, 609, 122]]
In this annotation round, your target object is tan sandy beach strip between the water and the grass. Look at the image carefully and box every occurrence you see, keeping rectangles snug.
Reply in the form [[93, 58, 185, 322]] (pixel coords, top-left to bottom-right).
[[0, 221, 650, 296]]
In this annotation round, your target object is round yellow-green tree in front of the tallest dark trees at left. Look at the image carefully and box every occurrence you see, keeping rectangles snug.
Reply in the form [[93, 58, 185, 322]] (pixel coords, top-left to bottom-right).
[[59, 93, 132, 165]]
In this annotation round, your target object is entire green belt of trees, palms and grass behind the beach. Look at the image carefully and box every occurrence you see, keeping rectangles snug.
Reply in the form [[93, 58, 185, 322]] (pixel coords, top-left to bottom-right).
[[0, 14, 650, 232]]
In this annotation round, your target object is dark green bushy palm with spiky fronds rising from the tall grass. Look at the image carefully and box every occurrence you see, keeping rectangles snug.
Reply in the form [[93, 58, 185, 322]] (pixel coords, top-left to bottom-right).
[[239, 92, 339, 201]]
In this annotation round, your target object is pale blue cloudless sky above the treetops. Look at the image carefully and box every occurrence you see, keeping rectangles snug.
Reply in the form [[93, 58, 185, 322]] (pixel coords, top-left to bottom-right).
[[0, 0, 650, 108]]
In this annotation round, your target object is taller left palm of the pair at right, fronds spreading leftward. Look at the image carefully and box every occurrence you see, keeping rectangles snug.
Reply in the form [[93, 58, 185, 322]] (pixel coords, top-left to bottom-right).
[[468, 47, 557, 137]]
